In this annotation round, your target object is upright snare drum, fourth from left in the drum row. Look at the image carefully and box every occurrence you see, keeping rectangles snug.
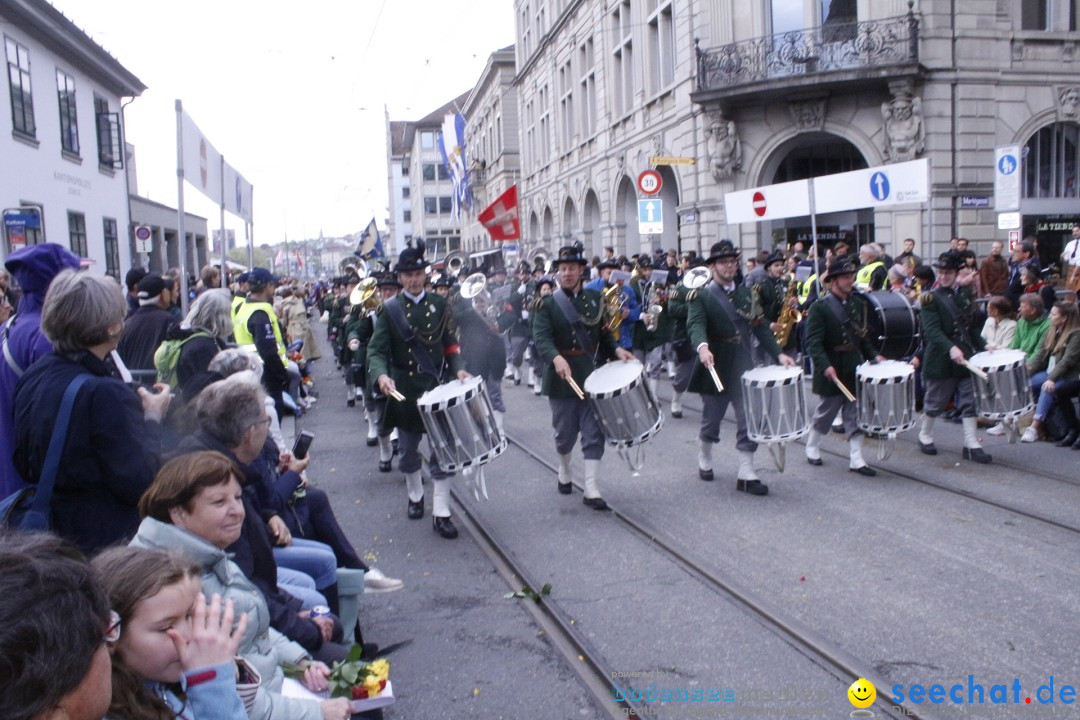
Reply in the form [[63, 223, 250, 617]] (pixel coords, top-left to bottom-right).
[[855, 361, 915, 434]]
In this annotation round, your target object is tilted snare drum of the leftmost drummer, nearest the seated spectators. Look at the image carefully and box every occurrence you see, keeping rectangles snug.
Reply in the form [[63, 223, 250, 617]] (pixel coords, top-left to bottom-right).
[[416, 377, 507, 473]]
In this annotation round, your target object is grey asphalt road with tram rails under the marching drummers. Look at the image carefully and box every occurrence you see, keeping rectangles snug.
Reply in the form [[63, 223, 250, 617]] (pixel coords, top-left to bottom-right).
[[302, 328, 1080, 718]]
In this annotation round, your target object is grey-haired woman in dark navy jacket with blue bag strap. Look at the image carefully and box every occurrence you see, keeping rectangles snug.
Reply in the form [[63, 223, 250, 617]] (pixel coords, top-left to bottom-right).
[[13, 270, 170, 554]]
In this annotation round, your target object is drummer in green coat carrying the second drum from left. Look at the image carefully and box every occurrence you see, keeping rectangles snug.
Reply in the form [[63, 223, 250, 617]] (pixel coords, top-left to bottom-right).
[[532, 243, 634, 511]]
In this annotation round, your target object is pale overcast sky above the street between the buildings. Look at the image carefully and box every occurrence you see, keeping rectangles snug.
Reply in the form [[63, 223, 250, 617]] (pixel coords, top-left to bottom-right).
[[50, 0, 514, 244]]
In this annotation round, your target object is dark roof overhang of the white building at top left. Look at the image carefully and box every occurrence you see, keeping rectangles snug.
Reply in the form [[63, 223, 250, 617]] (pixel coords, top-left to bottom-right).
[[0, 0, 146, 97]]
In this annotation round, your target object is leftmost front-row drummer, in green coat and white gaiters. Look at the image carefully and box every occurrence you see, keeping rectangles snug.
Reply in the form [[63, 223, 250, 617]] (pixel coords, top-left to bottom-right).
[[367, 241, 469, 540]]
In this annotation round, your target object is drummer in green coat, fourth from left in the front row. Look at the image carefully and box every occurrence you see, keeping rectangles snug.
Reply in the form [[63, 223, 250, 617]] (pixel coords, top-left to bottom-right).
[[806, 258, 885, 477]]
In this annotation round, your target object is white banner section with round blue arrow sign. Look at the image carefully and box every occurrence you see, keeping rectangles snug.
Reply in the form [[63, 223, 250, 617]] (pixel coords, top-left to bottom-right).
[[813, 159, 930, 215]]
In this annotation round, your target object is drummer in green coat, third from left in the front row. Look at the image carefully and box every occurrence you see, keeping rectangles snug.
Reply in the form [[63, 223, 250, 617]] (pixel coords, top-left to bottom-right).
[[687, 240, 795, 495]]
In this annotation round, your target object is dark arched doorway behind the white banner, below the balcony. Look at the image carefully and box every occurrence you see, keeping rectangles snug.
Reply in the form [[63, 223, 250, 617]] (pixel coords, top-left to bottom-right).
[[756, 133, 874, 252]]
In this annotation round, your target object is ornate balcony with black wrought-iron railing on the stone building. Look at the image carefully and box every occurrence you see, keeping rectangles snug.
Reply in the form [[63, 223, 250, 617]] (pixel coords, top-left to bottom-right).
[[693, 2, 919, 105]]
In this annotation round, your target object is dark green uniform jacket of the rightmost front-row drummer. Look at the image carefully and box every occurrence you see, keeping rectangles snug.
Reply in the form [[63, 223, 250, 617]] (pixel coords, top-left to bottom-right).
[[919, 287, 986, 380]]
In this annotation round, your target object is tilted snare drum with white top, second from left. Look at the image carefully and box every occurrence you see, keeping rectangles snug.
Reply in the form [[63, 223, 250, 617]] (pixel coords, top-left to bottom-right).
[[582, 361, 664, 448]]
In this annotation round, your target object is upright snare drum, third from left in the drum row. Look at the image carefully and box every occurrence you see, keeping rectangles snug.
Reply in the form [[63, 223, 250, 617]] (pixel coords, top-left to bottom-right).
[[742, 365, 810, 443]]
